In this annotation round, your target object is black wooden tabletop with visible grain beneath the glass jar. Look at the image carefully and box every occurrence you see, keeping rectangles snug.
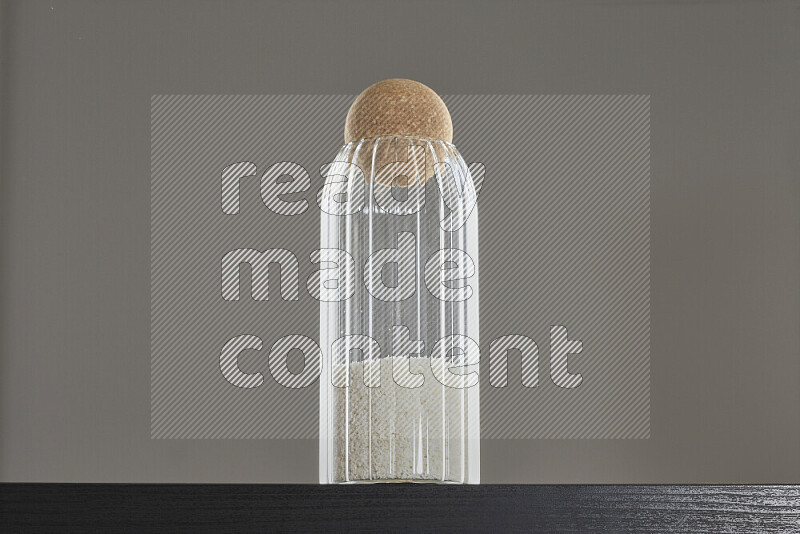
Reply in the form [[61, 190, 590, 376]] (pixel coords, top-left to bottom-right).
[[0, 484, 800, 533]]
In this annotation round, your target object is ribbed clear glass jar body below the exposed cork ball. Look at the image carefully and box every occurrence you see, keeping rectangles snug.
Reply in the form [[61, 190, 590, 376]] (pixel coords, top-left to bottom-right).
[[319, 136, 480, 484]]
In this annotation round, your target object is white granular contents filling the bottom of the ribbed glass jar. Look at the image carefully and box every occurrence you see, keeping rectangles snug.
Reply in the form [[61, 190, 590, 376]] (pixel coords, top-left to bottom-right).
[[332, 357, 470, 482]]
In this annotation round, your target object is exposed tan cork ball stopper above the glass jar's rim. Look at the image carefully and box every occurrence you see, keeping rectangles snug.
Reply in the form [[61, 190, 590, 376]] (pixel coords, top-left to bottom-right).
[[344, 78, 453, 143]]
